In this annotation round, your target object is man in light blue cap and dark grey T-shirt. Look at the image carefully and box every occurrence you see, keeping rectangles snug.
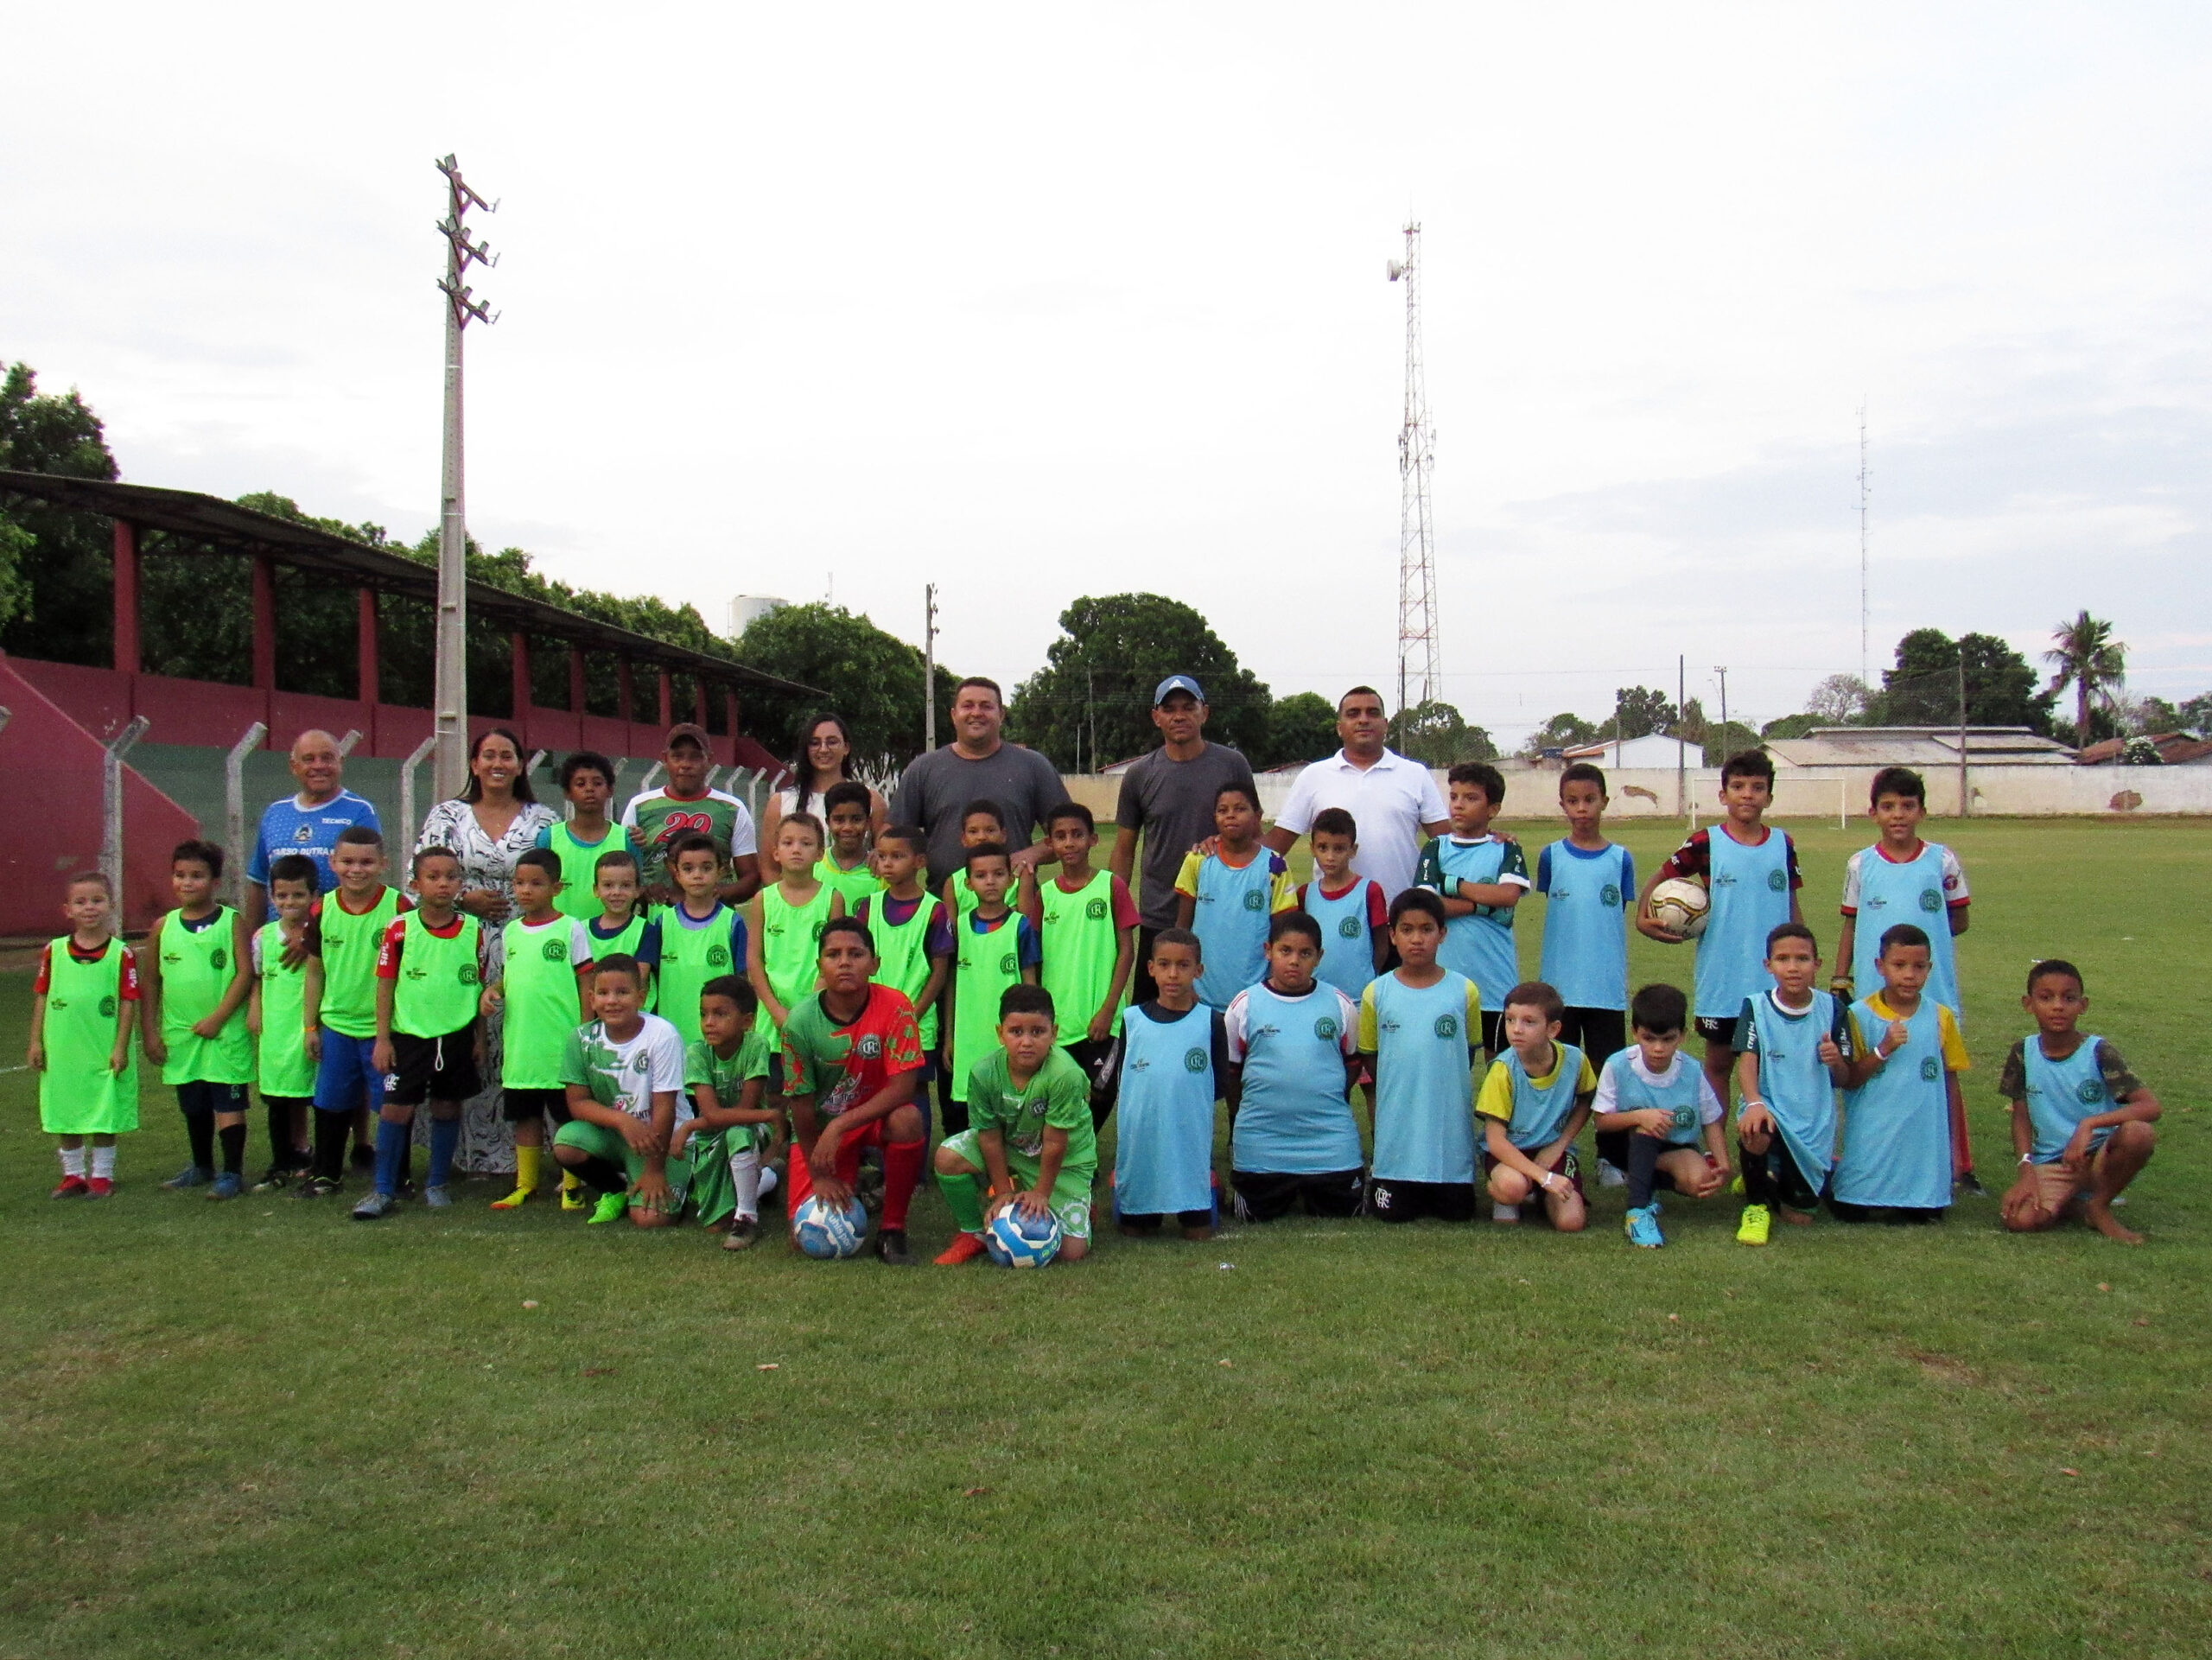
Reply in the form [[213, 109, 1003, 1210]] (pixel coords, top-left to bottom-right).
[[1106, 675, 1259, 1002]]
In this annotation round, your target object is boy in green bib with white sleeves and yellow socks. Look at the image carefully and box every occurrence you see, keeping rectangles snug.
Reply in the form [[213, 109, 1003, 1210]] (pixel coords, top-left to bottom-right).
[[482, 848, 593, 1211]]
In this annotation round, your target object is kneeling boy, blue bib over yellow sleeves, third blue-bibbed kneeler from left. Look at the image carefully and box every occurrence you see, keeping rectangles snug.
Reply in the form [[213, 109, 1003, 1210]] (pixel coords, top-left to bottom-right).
[[1360, 887, 1482, 1222]]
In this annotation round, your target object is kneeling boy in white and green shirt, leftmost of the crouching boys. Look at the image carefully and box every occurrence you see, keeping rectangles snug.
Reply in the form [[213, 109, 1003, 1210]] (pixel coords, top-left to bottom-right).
[[553, 956, 690, 1229]]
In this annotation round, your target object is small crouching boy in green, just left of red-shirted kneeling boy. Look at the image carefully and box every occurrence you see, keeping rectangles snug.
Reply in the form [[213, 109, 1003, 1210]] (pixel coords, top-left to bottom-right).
[[668, 974, 777, 1250]]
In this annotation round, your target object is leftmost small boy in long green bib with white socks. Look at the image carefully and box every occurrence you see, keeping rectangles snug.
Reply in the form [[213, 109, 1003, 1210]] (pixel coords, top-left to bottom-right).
[[24, 870, 139, 1199]]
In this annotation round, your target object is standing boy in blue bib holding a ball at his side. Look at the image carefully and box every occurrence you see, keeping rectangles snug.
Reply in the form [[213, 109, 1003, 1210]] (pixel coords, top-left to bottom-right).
[[1637, 750, 1805, 1133]]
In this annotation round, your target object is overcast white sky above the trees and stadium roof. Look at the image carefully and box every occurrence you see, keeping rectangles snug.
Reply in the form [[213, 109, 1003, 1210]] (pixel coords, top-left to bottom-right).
[[0, 0, 2212, 739]]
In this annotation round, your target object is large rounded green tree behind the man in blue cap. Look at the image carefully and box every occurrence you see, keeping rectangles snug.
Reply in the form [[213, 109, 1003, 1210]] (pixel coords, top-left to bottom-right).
[[1008, 593, 1274, 773]]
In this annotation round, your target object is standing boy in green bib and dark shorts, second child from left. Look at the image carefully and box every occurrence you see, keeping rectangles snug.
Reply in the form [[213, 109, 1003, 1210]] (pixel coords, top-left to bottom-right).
[[142, 841, 254, 1199]]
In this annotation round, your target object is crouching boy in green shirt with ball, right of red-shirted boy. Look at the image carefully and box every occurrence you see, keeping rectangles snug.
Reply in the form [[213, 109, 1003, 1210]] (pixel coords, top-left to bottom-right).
[[938, 985, 1099, 1269]]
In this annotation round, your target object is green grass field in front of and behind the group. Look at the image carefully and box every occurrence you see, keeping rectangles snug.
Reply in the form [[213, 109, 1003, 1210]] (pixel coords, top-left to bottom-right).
[[0, 824, 2212, 1660]]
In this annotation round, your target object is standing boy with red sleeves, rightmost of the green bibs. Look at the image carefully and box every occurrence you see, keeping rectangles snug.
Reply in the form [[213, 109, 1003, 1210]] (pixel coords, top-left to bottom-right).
[[1022, 801, 1137, 1129]]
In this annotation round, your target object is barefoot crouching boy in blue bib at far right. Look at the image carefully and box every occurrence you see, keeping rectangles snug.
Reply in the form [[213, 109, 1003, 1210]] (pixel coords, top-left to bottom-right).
[[1998, 958, 2159, 1243]]
